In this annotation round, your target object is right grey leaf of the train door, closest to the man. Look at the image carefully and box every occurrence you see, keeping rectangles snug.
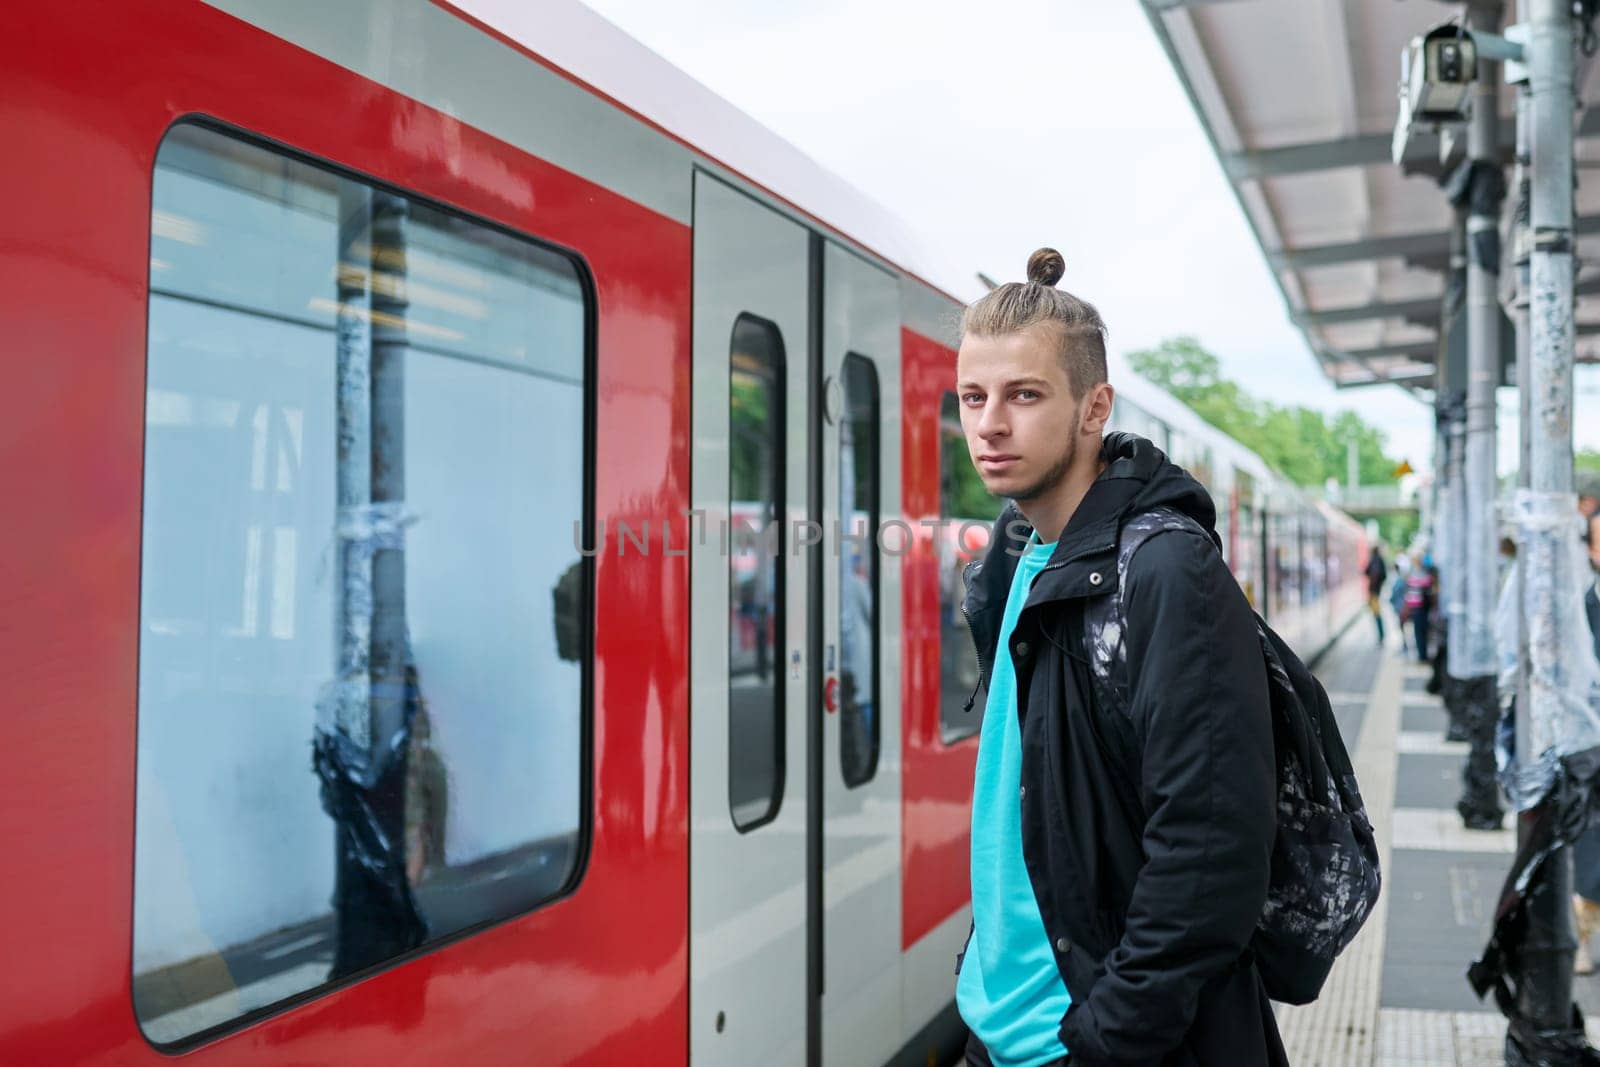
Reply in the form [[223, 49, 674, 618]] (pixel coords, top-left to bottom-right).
[[821, 243, 910, 1067]]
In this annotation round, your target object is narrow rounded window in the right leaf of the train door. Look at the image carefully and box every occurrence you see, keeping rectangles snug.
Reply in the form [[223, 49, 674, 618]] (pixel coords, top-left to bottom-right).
[[837, 354, 883, 785]]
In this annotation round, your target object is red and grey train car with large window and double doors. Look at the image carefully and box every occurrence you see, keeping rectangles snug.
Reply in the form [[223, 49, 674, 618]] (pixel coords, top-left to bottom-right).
[[0, 0, 1363, 1067]]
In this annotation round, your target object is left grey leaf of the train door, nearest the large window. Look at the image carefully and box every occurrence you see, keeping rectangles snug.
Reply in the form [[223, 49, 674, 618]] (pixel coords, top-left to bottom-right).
[[688, 174, 816, 1067]]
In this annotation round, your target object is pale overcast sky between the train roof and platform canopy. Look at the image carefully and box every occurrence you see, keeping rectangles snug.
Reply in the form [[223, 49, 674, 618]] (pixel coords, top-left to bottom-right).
[[572, 0, 1600, 469]]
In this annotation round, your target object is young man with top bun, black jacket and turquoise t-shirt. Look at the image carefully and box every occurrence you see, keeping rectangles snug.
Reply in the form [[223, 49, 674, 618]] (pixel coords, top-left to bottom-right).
[[957, 250, 1286, 1067]]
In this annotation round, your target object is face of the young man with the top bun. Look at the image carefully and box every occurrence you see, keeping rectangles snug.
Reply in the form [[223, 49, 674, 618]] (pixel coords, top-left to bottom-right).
[[955, 326, 1110, 501]]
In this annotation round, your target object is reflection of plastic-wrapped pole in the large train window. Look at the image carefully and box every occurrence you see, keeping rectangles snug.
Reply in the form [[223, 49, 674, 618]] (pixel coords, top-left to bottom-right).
[[315, 182, 427, 977]]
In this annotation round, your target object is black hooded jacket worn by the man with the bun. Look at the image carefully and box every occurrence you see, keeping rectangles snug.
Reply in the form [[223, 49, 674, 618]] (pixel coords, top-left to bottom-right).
[[963, 434, 1286, 1067]]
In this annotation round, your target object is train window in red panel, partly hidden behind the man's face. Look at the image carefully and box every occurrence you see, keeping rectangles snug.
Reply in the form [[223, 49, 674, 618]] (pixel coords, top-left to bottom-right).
[[934, 392, 1005, 744]]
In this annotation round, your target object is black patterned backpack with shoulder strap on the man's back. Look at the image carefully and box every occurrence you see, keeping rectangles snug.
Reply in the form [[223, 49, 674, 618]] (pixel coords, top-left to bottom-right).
[[1085, 507, 1381, 1005]]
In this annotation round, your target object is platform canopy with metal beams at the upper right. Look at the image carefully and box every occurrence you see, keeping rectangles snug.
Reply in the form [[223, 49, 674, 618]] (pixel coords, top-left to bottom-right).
[[1141, 0, 1600, 390]]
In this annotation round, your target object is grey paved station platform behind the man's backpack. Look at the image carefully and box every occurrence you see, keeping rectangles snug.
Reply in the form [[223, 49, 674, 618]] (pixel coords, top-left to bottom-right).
[[1277, 614, 1600, 1067]]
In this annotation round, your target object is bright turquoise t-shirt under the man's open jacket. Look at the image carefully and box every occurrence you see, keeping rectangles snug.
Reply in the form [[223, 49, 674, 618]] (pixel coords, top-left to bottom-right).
[[955, 541, 1072, 1067]]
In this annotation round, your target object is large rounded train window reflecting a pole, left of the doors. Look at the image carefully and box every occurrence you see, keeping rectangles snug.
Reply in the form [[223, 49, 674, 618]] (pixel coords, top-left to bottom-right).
[[133, 125, 592, 1045]]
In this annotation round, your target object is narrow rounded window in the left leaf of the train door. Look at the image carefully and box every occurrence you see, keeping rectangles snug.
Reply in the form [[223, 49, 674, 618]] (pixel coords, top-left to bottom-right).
[[728, 315, 786, 830]]
